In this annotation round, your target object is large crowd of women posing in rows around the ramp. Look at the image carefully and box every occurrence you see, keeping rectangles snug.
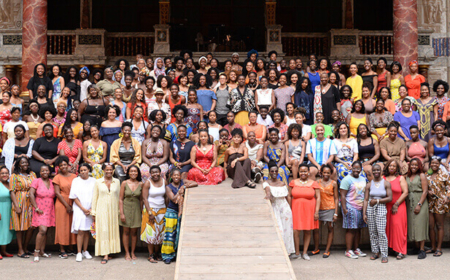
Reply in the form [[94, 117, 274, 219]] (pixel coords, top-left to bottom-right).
[[0, 50, 450, 264]]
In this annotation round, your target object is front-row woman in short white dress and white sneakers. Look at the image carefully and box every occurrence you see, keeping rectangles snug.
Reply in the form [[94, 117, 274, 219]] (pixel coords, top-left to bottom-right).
[[69, 163, 95, 262]]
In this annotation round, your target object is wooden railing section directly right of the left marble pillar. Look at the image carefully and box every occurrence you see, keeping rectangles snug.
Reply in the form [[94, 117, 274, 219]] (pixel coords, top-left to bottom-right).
[[47, 30, 76, 55]]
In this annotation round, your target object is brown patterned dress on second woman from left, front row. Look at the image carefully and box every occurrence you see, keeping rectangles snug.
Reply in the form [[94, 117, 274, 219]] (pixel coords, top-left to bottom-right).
[[9, 171, 36, 231]]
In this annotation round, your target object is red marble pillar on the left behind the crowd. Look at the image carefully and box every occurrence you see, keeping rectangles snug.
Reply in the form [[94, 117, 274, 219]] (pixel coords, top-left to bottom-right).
[[22, 0, 47, 93]]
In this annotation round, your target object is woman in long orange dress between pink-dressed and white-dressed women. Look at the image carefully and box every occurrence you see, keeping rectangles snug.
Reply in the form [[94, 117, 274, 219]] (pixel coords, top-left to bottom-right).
[[53, 156, 78, 259]]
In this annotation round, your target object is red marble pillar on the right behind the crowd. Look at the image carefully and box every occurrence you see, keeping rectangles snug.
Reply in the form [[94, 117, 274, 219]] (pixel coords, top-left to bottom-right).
[[393, 0, 418, 76]]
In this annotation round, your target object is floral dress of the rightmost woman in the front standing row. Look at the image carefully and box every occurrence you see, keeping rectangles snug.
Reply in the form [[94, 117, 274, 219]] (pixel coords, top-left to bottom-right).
[[427, 170, 450, 214]]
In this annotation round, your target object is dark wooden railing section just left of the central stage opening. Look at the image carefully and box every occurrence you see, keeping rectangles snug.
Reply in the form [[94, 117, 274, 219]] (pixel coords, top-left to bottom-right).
[[106, 32, 155, 56]]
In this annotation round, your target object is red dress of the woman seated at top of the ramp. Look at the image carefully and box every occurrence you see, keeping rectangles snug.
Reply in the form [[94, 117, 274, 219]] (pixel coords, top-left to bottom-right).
[[188, 146, 225, 185]]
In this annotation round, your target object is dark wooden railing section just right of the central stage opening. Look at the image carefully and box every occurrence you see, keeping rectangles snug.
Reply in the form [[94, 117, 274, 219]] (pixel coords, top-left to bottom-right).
[[281, 32, 330, 56]]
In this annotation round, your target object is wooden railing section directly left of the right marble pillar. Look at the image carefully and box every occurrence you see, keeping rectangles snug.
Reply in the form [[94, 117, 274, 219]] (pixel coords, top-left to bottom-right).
[[359, 31, 394, 55]]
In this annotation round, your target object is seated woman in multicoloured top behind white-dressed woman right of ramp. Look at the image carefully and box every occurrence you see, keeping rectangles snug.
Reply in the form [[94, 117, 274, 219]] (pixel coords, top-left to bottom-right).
[[263, 129, 290, 186]]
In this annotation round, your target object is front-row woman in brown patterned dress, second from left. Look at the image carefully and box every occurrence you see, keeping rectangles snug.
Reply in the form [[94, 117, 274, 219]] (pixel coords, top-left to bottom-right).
[[9, 156, 36, 258]]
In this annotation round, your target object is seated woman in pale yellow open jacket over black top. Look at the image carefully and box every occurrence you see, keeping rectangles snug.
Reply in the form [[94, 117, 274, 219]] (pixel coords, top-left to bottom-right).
[[110, 122, 141, 183]]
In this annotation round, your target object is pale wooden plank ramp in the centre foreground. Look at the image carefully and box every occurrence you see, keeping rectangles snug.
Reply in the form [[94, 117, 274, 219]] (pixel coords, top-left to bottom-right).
[[175, 179, 296, 280]]
